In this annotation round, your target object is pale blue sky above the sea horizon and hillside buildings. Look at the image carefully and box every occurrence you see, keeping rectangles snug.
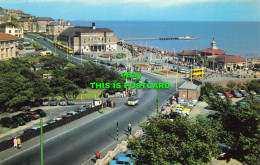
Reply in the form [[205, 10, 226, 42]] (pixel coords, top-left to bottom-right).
[[0, 0, 260, 21]]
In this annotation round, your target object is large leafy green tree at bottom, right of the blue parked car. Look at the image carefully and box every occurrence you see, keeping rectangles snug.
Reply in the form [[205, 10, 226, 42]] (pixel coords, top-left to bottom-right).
[[128, 117, 221, 165]]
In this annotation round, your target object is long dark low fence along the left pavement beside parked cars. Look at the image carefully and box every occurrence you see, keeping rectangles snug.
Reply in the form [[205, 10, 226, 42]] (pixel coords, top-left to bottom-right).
[[0, 104, 103, 152]]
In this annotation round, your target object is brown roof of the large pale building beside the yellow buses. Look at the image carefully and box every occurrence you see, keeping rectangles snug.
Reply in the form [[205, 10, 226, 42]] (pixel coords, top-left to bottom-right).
[[60, 26, 113, 37]]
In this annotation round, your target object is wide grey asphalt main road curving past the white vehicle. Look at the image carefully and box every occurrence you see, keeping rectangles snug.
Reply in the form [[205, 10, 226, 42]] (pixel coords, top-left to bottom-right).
[[0, 34, 185, 165]]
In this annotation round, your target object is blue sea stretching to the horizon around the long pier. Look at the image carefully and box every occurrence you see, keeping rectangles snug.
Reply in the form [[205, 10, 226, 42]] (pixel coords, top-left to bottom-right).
[[71, 21, 260, 58]]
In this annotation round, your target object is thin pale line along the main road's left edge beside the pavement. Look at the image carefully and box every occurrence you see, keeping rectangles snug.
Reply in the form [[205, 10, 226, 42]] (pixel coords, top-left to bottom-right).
[[0, 106, 121, 164]]
